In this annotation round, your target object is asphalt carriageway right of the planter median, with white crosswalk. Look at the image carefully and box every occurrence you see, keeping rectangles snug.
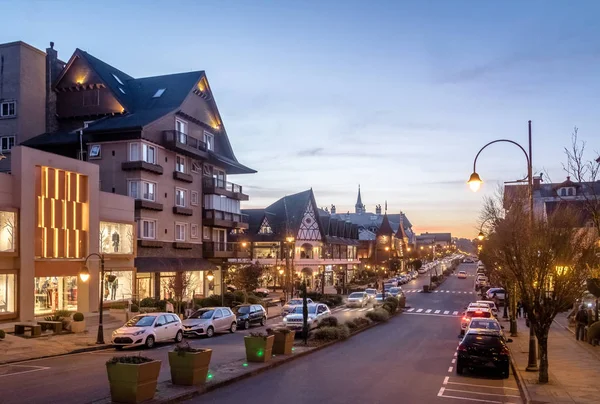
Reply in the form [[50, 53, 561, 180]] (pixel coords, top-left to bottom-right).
[[190, 264, 522, 404]]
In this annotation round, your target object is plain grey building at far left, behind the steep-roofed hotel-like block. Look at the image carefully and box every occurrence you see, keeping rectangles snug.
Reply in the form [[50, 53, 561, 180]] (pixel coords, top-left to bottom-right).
[[0, 41, 64, 172]]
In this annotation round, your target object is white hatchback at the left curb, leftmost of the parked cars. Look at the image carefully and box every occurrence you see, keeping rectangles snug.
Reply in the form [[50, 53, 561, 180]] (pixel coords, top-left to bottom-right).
[[110, 313, 183, 349]]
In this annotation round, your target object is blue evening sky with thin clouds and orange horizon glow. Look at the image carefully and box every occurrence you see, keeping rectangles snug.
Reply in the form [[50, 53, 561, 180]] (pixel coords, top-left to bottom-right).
[[0, 0, 600, 238]]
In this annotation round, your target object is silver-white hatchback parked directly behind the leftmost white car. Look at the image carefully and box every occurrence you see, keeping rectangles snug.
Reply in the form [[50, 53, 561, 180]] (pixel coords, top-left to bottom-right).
[[183, 307, 237, 338]]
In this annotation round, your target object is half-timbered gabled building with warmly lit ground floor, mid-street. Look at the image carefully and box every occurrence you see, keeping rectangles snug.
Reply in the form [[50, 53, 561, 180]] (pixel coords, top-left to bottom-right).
[[236, 189, 359, 290]]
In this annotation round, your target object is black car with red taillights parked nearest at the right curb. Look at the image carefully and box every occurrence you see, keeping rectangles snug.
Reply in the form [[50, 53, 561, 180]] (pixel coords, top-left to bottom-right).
[[456, 329, 512, 379]]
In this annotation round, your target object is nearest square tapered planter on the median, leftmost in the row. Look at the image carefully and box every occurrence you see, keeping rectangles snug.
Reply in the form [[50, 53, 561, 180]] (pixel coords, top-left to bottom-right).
[[106, 356, 161, 403]]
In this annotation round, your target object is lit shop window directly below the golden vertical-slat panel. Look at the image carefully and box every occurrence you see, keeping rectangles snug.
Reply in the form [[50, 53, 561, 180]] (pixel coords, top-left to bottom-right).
[[34, 276, 77, 314]]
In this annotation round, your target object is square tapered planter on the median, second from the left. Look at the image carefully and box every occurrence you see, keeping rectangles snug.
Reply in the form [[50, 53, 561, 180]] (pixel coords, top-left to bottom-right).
[[169, 343, 212, 386]]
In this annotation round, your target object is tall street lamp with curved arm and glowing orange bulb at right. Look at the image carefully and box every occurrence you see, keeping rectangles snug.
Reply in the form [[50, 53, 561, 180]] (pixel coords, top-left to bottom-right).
[[467, 121, 538, 372]]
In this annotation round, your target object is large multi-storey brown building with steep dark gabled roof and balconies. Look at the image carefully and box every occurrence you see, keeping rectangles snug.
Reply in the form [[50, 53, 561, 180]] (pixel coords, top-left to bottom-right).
[[20, 43, 255, 299]]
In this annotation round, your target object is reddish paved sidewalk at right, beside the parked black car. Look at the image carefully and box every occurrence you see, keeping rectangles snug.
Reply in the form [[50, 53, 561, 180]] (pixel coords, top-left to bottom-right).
[[509, 319, 600, 404]]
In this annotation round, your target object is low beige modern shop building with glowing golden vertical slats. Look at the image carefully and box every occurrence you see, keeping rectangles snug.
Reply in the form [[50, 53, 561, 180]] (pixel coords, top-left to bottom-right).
[[0, 146, 136, 322]]
